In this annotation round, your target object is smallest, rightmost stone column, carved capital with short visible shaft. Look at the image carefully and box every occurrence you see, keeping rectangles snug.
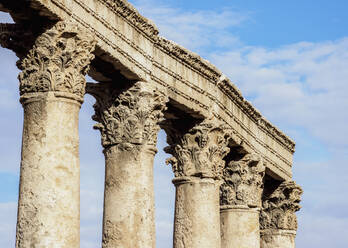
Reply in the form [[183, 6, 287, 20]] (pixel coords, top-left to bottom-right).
[[260, 181, 302, 248]]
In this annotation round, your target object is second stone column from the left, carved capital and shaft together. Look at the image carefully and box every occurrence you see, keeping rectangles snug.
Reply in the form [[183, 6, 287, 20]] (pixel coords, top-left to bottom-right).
[[88, 82, 167, 248]]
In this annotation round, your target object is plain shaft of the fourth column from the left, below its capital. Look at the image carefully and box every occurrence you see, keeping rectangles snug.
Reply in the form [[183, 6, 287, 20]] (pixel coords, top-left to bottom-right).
[[220, 206, 260, 248]]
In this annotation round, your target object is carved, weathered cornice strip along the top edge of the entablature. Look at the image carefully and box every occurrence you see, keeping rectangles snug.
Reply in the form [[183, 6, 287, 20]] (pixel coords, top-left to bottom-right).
[[98, 0, 295, 153]]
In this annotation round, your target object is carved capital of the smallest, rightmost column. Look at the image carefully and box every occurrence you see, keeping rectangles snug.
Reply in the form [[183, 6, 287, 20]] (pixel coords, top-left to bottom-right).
[[260, 181, 303, 231]]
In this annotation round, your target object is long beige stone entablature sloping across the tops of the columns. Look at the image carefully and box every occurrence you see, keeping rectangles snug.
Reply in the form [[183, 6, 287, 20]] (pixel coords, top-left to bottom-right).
[[0, 0, 295, 180]]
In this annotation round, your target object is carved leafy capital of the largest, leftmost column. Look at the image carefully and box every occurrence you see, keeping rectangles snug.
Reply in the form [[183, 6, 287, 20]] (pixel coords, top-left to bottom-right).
[[19, 21, 95, 99]]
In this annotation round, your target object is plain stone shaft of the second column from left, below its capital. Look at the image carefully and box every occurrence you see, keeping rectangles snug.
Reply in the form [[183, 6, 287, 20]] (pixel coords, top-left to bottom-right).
[[103, 146, 156, 248]]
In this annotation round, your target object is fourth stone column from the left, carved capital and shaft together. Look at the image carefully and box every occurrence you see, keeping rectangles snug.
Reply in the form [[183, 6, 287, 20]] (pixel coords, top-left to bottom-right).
[[220, 154, 265, 248]]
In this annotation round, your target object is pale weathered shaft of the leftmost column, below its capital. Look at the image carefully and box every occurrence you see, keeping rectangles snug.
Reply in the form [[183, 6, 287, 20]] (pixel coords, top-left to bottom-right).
[[16, 93, 80, 248]]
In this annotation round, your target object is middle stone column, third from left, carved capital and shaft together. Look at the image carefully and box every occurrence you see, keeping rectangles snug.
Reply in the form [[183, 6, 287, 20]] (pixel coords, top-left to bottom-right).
[[166, 120, 229, 248]]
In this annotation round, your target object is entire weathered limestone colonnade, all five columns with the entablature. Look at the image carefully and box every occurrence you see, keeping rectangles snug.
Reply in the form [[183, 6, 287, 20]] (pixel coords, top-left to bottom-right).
[[0, 0, 302, 248]]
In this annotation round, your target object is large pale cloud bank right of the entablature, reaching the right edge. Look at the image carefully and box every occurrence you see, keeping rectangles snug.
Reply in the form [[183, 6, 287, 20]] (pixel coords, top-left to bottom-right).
[[210, 38, 348, 149]]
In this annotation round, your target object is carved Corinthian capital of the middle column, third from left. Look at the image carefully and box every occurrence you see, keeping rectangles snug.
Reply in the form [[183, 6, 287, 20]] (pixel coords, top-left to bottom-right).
[[165, 120, 231, 178]]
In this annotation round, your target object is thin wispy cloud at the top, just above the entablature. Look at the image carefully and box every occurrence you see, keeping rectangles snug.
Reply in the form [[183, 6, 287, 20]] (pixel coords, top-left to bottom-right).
[[130, 0, 249, 51]]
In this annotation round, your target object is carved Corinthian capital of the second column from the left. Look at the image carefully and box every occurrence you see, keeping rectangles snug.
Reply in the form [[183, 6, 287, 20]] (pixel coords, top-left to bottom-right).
[[87, 82, 167, 148]]
